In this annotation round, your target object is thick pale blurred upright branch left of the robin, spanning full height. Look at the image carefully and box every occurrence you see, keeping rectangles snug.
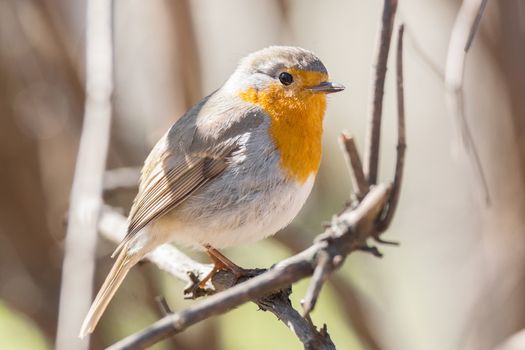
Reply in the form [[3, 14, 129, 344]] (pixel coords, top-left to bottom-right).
[[56, 0, 113, 350]]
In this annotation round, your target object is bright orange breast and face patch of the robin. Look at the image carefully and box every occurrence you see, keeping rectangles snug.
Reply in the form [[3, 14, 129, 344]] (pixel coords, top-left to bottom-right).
[[240, 72, 326, 183]]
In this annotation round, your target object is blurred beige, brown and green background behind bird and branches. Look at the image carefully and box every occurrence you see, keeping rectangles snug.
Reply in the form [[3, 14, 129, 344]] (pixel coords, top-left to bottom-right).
[[0, 0, 525, 350]]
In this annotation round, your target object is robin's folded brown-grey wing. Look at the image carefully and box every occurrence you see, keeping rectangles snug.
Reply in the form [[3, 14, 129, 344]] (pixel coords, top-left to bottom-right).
[[113, 91, 262, 256]]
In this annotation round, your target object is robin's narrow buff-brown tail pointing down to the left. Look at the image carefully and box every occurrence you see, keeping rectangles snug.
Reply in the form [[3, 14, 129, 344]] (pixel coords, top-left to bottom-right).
[[79, 245, 134, 338]]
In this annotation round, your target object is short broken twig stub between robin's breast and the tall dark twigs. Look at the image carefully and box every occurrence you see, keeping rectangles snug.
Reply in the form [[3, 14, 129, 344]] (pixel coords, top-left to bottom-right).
[[340, 132, 368, 200]]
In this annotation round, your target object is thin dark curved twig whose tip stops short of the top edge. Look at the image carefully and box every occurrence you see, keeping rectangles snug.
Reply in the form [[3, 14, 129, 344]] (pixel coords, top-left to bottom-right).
[[379, 24, 407, 232]]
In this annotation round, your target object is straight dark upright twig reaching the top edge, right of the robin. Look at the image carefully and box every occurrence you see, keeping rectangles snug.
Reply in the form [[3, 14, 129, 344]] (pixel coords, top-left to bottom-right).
[[364, 0, 397, 185]]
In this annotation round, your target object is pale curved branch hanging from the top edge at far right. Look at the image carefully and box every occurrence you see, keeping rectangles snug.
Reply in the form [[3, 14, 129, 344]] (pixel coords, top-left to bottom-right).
[[445, 0, 490, 204]]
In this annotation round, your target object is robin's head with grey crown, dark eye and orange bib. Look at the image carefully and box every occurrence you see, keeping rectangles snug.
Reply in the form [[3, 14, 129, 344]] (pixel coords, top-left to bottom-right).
[[224, 46, 344, 182]]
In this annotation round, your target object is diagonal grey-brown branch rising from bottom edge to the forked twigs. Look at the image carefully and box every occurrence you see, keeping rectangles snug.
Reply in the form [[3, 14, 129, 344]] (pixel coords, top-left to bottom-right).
[[108, 184, 389, 350]]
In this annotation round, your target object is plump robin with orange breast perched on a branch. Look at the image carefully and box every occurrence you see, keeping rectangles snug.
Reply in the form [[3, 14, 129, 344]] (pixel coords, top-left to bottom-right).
[[79, 46, 344, 338]]
